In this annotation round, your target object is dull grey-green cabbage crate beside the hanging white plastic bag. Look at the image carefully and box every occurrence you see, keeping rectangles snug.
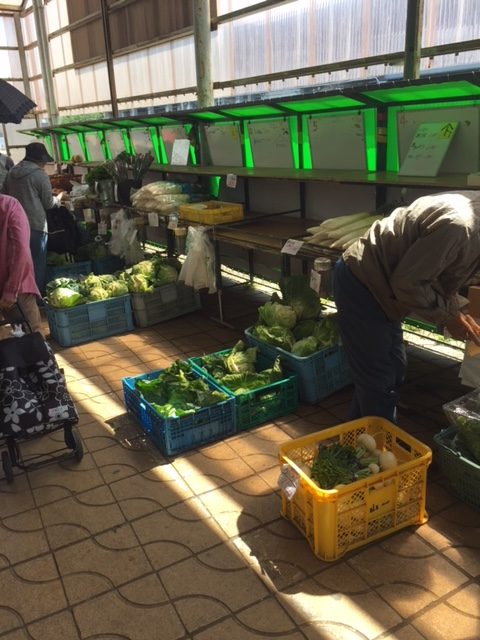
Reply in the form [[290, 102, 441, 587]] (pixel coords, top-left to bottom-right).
[[132, 282, 200, 327]]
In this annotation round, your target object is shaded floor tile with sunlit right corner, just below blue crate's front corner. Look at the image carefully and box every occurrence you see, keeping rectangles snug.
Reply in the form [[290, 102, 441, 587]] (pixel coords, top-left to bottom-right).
[[110, 464, 193, 519]]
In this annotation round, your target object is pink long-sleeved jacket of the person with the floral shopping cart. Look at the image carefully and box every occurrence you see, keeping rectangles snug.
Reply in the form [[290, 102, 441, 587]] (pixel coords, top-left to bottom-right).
[[0, 194, 43, 337]]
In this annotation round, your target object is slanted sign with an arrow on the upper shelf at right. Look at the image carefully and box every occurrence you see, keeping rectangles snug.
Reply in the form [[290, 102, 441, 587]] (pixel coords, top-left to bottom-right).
[[398, 122, 458, 177]]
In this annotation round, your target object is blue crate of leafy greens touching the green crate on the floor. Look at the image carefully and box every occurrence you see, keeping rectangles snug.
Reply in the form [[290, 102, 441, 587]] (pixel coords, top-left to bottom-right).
[[122, 369, 235, 456]]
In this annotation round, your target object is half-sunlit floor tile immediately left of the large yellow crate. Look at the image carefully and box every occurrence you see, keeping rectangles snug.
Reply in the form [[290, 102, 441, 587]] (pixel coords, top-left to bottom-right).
[[200, 476, 280, 538]]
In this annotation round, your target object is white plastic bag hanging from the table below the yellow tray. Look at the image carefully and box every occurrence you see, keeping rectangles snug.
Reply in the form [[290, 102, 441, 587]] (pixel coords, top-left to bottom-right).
[[178, 227, 217, 293]]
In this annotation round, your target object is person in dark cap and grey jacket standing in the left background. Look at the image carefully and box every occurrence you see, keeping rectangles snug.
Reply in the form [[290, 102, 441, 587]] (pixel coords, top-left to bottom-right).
[[4, 142, 63, 293]]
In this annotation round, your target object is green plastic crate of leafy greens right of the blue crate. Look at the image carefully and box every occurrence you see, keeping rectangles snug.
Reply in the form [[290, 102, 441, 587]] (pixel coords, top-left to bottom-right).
[[189, 349, 298, 432]]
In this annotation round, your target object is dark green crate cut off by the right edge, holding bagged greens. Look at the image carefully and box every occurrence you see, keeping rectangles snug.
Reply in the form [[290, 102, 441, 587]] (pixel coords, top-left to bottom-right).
[[433, 427, 480, 509]]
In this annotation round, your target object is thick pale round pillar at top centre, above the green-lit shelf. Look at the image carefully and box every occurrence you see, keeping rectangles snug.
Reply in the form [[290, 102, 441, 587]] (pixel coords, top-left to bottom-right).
[[193, 0, 213, 107]]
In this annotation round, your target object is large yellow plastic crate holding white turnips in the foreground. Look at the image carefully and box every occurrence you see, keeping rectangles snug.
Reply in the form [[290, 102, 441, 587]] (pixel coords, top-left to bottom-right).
[[279, 417, 432, 561]]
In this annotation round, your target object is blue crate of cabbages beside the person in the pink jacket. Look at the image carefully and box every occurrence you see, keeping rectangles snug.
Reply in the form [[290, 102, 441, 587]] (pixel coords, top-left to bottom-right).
[[46, 294, 133, 347]]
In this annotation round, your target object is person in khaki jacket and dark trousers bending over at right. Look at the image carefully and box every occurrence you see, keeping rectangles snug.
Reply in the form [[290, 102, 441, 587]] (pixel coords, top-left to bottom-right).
[[334, 191, 480, 422]]
